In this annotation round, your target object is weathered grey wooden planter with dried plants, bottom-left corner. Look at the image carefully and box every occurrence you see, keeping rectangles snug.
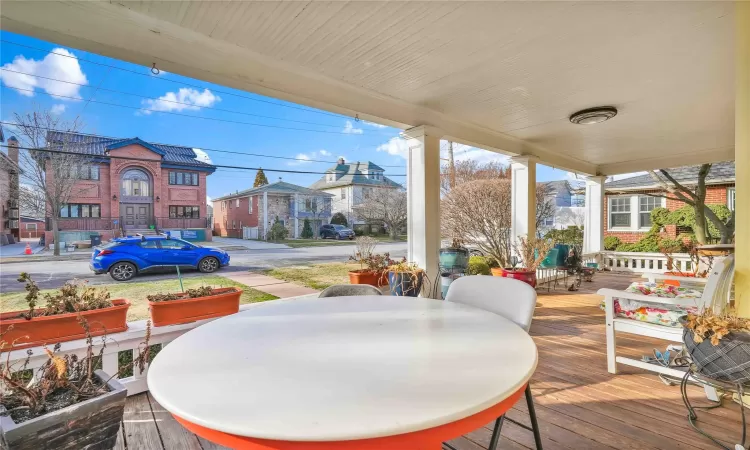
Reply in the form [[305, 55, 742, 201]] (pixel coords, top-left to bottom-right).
[[0, 315, 150, 450]]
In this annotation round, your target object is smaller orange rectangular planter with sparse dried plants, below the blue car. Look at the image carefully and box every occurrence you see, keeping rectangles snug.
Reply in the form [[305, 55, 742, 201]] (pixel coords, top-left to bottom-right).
[[146, 286, 242, 327]]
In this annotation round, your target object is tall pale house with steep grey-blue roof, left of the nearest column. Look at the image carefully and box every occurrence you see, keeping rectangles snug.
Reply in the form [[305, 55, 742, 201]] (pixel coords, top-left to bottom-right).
[[310, 158, 403, 228]]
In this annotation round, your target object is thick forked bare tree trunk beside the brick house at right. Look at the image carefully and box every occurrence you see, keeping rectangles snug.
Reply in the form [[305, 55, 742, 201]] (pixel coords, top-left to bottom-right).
[[649, 164, 734, 244]]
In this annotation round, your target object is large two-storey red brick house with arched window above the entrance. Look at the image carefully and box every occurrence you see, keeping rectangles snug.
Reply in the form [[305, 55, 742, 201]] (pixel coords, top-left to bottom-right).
[[46, 131, 216, 243]]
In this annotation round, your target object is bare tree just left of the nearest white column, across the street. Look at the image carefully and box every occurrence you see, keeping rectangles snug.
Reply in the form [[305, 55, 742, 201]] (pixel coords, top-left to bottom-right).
[[353, 189, 407, 239]]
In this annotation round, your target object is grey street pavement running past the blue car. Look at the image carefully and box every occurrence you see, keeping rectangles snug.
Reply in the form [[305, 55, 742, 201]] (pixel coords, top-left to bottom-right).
[[0, 242, 407, 293]]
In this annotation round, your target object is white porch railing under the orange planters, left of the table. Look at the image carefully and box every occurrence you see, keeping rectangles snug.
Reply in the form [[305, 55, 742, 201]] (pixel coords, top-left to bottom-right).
[[0, 294, 317, 395]]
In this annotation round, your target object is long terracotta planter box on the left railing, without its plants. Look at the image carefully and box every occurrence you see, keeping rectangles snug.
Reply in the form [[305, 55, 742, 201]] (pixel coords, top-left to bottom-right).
[[0, 299, 130, 350]]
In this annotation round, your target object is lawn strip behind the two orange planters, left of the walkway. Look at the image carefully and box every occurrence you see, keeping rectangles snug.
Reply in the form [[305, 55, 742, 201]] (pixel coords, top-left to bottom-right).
[[0, 275, 277, 321]]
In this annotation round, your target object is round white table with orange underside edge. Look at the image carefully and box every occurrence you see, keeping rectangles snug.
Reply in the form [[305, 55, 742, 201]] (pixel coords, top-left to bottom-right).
[[148, 296, 537, 450]]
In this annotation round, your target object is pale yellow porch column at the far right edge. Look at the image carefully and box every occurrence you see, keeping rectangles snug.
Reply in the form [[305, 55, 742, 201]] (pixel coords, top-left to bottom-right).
[[734, 2, 750, 318]]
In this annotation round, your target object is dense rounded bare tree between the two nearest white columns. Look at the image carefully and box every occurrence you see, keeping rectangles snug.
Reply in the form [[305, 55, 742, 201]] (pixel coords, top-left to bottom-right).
[[441, 179, 511, 267]]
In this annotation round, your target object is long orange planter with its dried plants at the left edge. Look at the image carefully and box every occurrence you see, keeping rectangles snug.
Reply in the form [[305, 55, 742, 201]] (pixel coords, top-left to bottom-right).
[[0, 272, 130, 349]]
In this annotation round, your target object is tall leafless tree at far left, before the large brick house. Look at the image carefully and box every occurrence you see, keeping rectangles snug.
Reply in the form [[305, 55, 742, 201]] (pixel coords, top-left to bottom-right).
[[14, 109, 89, 256]]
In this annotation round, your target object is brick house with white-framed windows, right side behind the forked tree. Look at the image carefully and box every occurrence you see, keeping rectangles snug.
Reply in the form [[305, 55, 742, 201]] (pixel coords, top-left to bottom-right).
[[604, 161, 735, 243]]
